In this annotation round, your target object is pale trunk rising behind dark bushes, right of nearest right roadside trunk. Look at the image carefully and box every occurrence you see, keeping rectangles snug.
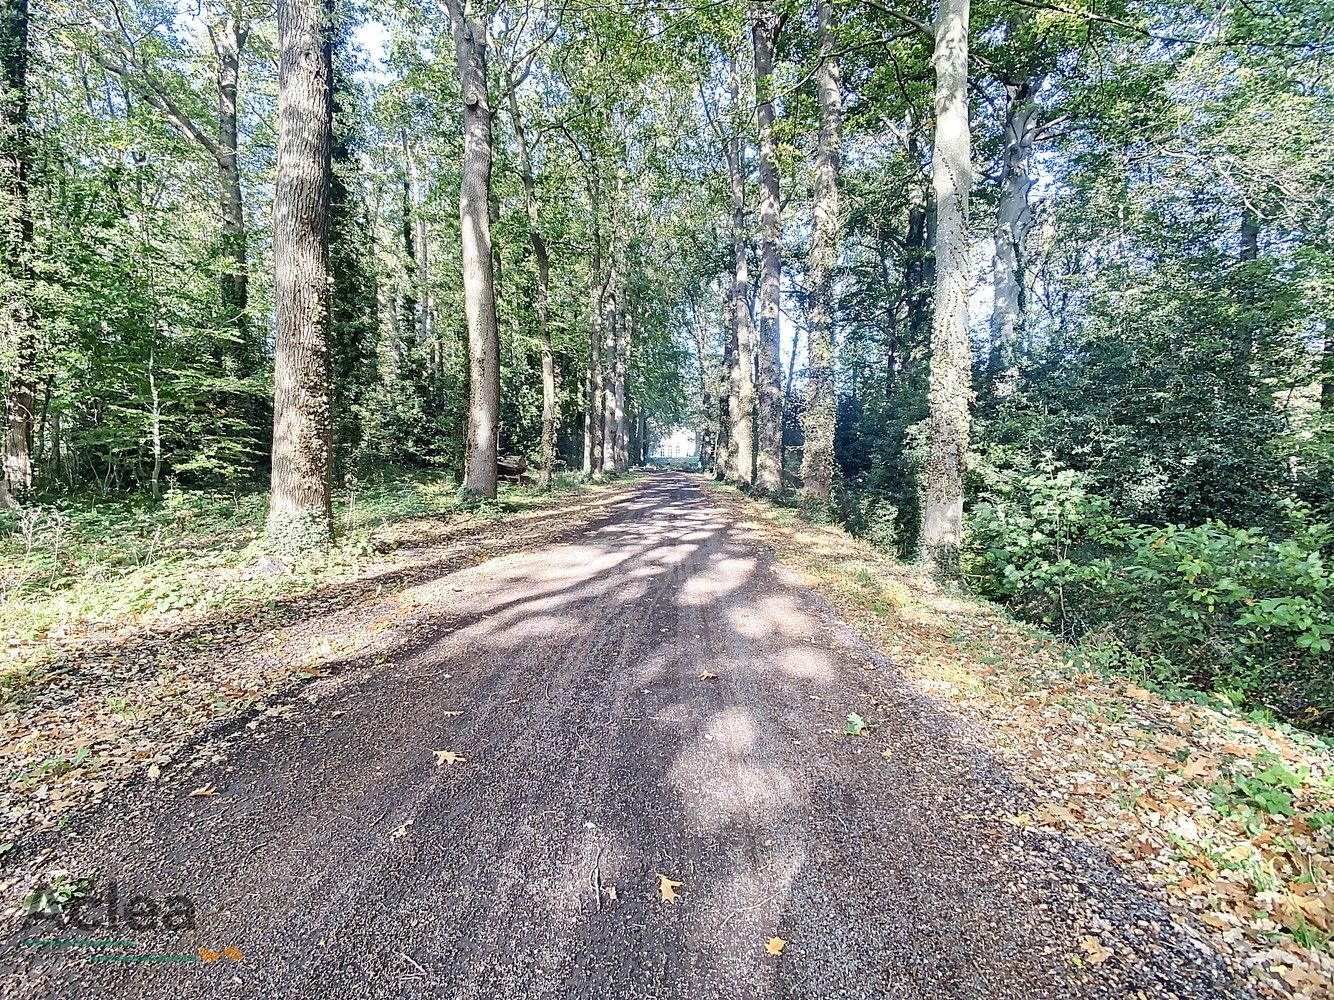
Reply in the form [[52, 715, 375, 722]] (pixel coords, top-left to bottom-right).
[[987, 81, 1038, 388]]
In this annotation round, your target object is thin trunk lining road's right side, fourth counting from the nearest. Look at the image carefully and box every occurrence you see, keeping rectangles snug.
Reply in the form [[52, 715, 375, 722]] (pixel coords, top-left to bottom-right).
[[726, 63, 755, 487]]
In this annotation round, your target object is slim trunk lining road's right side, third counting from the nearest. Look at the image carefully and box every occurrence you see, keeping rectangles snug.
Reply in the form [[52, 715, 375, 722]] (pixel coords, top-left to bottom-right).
[[751, 8, 783, 493]]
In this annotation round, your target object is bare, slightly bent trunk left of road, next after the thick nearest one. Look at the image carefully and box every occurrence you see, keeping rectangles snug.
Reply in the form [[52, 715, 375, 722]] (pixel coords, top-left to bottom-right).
[[446, 0, 500, 497]]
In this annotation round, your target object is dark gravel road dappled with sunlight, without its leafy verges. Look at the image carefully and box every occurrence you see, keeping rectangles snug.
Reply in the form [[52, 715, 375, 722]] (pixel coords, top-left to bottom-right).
[[0, 473, 1246, 1000]]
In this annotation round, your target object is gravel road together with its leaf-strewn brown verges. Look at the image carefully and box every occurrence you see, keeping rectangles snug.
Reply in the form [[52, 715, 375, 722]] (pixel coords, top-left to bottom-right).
[[0, 473, 1331, 999]]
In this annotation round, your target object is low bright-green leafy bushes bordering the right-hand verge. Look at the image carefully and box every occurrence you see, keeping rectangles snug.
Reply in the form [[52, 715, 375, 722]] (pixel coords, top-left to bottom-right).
[[964, 467, 1334, 728]]
